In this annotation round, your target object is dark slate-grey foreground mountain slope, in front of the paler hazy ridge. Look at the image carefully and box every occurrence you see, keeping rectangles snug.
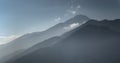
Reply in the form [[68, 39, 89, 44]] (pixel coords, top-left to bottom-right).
[[6, 19, 120, 63]]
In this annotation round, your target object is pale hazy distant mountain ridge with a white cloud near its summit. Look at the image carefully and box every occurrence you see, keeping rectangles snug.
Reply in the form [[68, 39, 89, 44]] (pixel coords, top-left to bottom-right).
[[0, 15, 89, 58]]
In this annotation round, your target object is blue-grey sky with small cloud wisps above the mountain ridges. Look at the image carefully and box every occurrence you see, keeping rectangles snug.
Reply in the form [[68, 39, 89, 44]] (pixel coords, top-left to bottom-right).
[[0, 0, 120, 36]]
